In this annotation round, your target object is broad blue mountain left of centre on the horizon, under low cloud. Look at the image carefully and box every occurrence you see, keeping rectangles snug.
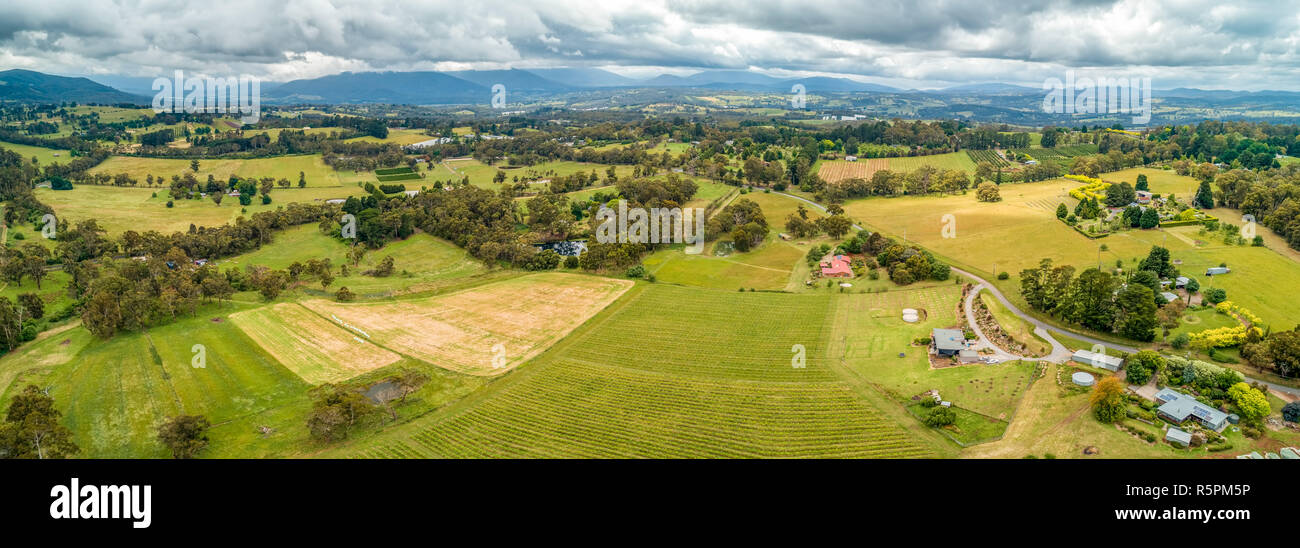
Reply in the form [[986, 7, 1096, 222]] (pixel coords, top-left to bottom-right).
[[263, 71, 490, 105]]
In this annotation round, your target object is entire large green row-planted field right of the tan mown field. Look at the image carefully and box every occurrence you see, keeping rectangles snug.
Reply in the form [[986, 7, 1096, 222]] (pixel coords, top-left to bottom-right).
[[326, 284, 933, 457]]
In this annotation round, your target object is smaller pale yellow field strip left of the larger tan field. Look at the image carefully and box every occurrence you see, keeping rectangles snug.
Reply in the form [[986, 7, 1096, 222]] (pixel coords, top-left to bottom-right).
[[230, 303, 402, 384]]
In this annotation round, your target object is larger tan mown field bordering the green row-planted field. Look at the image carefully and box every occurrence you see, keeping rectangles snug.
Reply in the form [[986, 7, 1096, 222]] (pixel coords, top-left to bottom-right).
[[303, 273, 632, 377]]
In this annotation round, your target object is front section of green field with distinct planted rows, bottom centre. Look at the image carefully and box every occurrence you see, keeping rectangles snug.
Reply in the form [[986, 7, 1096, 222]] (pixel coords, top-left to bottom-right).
[[360, 361, 928, 458]]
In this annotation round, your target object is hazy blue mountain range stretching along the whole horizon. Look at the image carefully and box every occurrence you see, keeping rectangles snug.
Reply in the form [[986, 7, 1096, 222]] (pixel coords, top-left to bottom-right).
[[0, 68, 1300, 125]]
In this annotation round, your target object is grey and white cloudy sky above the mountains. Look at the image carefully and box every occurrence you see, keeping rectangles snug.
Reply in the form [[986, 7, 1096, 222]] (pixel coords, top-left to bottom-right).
[[0, 0, 1300, 90]]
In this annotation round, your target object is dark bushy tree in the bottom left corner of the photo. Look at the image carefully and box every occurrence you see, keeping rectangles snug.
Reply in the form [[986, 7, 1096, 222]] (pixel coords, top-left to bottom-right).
[[0, 384, 81, 458]]
